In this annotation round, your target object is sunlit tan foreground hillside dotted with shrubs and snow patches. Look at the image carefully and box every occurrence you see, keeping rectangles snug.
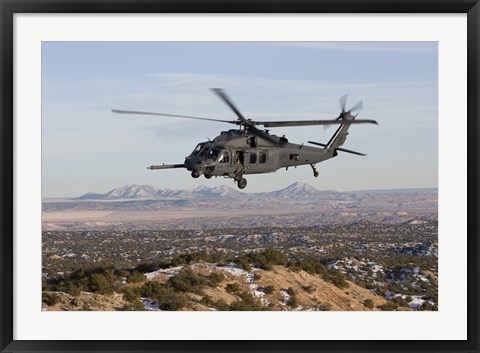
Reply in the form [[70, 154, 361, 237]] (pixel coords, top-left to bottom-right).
[[42, 263, 386, 311]]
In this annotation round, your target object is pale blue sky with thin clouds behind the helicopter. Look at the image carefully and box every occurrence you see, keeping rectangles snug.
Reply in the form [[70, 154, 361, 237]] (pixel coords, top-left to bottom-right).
[[42, 42, 438, 197]]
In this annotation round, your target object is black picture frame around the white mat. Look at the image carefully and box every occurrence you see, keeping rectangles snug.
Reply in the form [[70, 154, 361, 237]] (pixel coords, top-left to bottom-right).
[[0, 0, 480, 352]]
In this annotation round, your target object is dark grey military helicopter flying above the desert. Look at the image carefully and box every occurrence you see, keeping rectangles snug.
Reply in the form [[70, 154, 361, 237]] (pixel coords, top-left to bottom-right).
[[112, 88, 378, 189]]
